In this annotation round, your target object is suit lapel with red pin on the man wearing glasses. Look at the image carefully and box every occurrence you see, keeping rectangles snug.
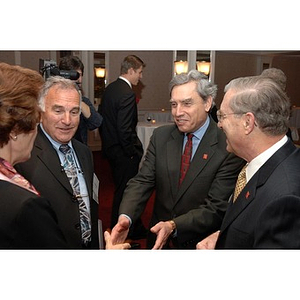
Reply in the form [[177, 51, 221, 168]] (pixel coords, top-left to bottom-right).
[[221, 141, 295, 232]]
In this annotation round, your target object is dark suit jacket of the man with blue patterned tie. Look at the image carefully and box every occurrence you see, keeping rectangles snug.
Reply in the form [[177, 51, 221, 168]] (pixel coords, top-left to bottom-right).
[[15, 127, 99, 249]]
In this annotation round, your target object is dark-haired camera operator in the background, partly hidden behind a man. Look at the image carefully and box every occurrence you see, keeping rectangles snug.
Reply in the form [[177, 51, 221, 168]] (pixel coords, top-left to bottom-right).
[[59, 55, 103, 145]]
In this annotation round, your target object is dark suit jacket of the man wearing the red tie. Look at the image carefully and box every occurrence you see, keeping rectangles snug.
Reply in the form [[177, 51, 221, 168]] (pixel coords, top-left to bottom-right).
[[119, 120, 245, 248]]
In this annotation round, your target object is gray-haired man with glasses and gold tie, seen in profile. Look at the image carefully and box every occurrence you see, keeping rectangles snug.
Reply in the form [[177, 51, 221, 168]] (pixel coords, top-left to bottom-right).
[[197, 76, 300, 249]]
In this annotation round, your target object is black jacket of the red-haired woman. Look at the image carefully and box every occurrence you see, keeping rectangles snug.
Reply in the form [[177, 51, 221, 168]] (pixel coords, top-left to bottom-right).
[[0, 180, 68, 249]]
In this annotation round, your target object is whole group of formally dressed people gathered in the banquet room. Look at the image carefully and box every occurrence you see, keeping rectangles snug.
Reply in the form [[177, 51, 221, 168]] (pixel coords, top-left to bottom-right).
[[0, 55, 300, 250]]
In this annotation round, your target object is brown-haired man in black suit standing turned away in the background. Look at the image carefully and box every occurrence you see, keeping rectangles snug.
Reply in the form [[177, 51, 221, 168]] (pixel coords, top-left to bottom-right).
[[100, 55, 145, 239]]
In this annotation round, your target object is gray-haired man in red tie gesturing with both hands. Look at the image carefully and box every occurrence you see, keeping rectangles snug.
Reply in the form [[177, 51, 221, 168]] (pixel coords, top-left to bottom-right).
[[111, 70, 245, 249]]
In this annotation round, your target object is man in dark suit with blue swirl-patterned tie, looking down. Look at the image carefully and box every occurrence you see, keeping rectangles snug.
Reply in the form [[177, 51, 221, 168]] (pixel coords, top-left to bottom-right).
[[16, 77, 99, 249]]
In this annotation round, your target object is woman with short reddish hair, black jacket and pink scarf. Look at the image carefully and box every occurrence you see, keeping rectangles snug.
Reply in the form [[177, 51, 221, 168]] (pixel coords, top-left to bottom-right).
[[0, 63, 68, 249]]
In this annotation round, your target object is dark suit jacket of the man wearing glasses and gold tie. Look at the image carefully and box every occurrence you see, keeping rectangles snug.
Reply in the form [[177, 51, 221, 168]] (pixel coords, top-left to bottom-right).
[[216, 140, 300, 249]]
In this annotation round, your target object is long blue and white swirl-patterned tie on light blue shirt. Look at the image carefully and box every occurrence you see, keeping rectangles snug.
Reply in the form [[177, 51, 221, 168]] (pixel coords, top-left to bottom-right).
[[59, 144, 91, 244]]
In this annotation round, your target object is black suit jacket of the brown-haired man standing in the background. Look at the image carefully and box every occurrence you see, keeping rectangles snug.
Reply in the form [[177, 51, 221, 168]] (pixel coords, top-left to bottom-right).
[[101, 78, 143, 159]]
